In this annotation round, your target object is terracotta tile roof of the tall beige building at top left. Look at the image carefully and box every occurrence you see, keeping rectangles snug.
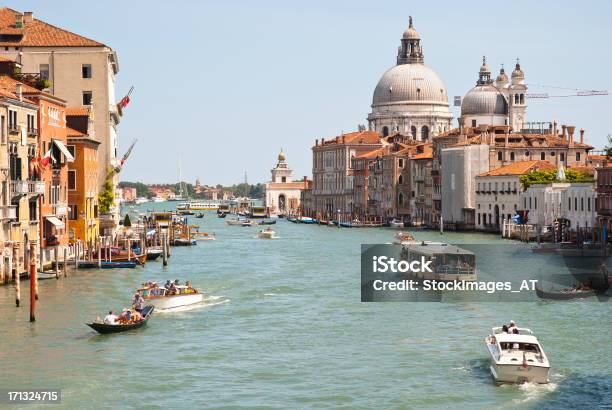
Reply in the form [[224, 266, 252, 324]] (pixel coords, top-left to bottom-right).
[[0, 7, 104, 47]]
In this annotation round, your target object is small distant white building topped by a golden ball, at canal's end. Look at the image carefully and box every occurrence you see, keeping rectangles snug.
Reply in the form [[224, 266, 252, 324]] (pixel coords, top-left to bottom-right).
[[265, 150, 306, 215]]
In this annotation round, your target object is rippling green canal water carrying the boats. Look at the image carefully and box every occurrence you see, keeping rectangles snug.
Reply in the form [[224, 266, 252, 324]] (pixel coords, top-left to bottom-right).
[[0, 204, 612, 409]]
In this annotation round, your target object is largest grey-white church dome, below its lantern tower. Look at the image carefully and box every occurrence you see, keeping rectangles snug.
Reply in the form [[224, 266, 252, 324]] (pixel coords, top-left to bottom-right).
[[372, 64, 448, 106]]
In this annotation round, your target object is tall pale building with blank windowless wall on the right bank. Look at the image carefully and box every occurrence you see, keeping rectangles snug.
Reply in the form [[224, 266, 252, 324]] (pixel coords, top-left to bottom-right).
[[442, 144, 489, 228]]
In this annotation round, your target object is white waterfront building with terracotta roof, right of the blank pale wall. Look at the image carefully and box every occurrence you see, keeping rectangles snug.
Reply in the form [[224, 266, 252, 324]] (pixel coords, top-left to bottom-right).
[[476, 161, 555, 231]]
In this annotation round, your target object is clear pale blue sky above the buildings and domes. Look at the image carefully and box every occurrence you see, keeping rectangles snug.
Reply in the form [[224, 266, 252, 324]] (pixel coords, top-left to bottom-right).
[[5, 0, 612, 185]]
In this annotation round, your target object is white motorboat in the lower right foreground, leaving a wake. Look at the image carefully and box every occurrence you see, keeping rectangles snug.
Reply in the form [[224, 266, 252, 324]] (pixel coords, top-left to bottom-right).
[[485, 327, 550, 384]]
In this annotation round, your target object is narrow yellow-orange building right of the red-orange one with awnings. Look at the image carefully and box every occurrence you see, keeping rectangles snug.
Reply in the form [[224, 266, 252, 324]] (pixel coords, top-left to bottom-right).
[[66, 107, 100, 246]]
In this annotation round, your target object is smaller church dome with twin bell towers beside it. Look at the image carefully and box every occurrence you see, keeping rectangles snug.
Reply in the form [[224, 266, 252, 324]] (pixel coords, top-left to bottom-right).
[[461, 57, 527, 132]]
